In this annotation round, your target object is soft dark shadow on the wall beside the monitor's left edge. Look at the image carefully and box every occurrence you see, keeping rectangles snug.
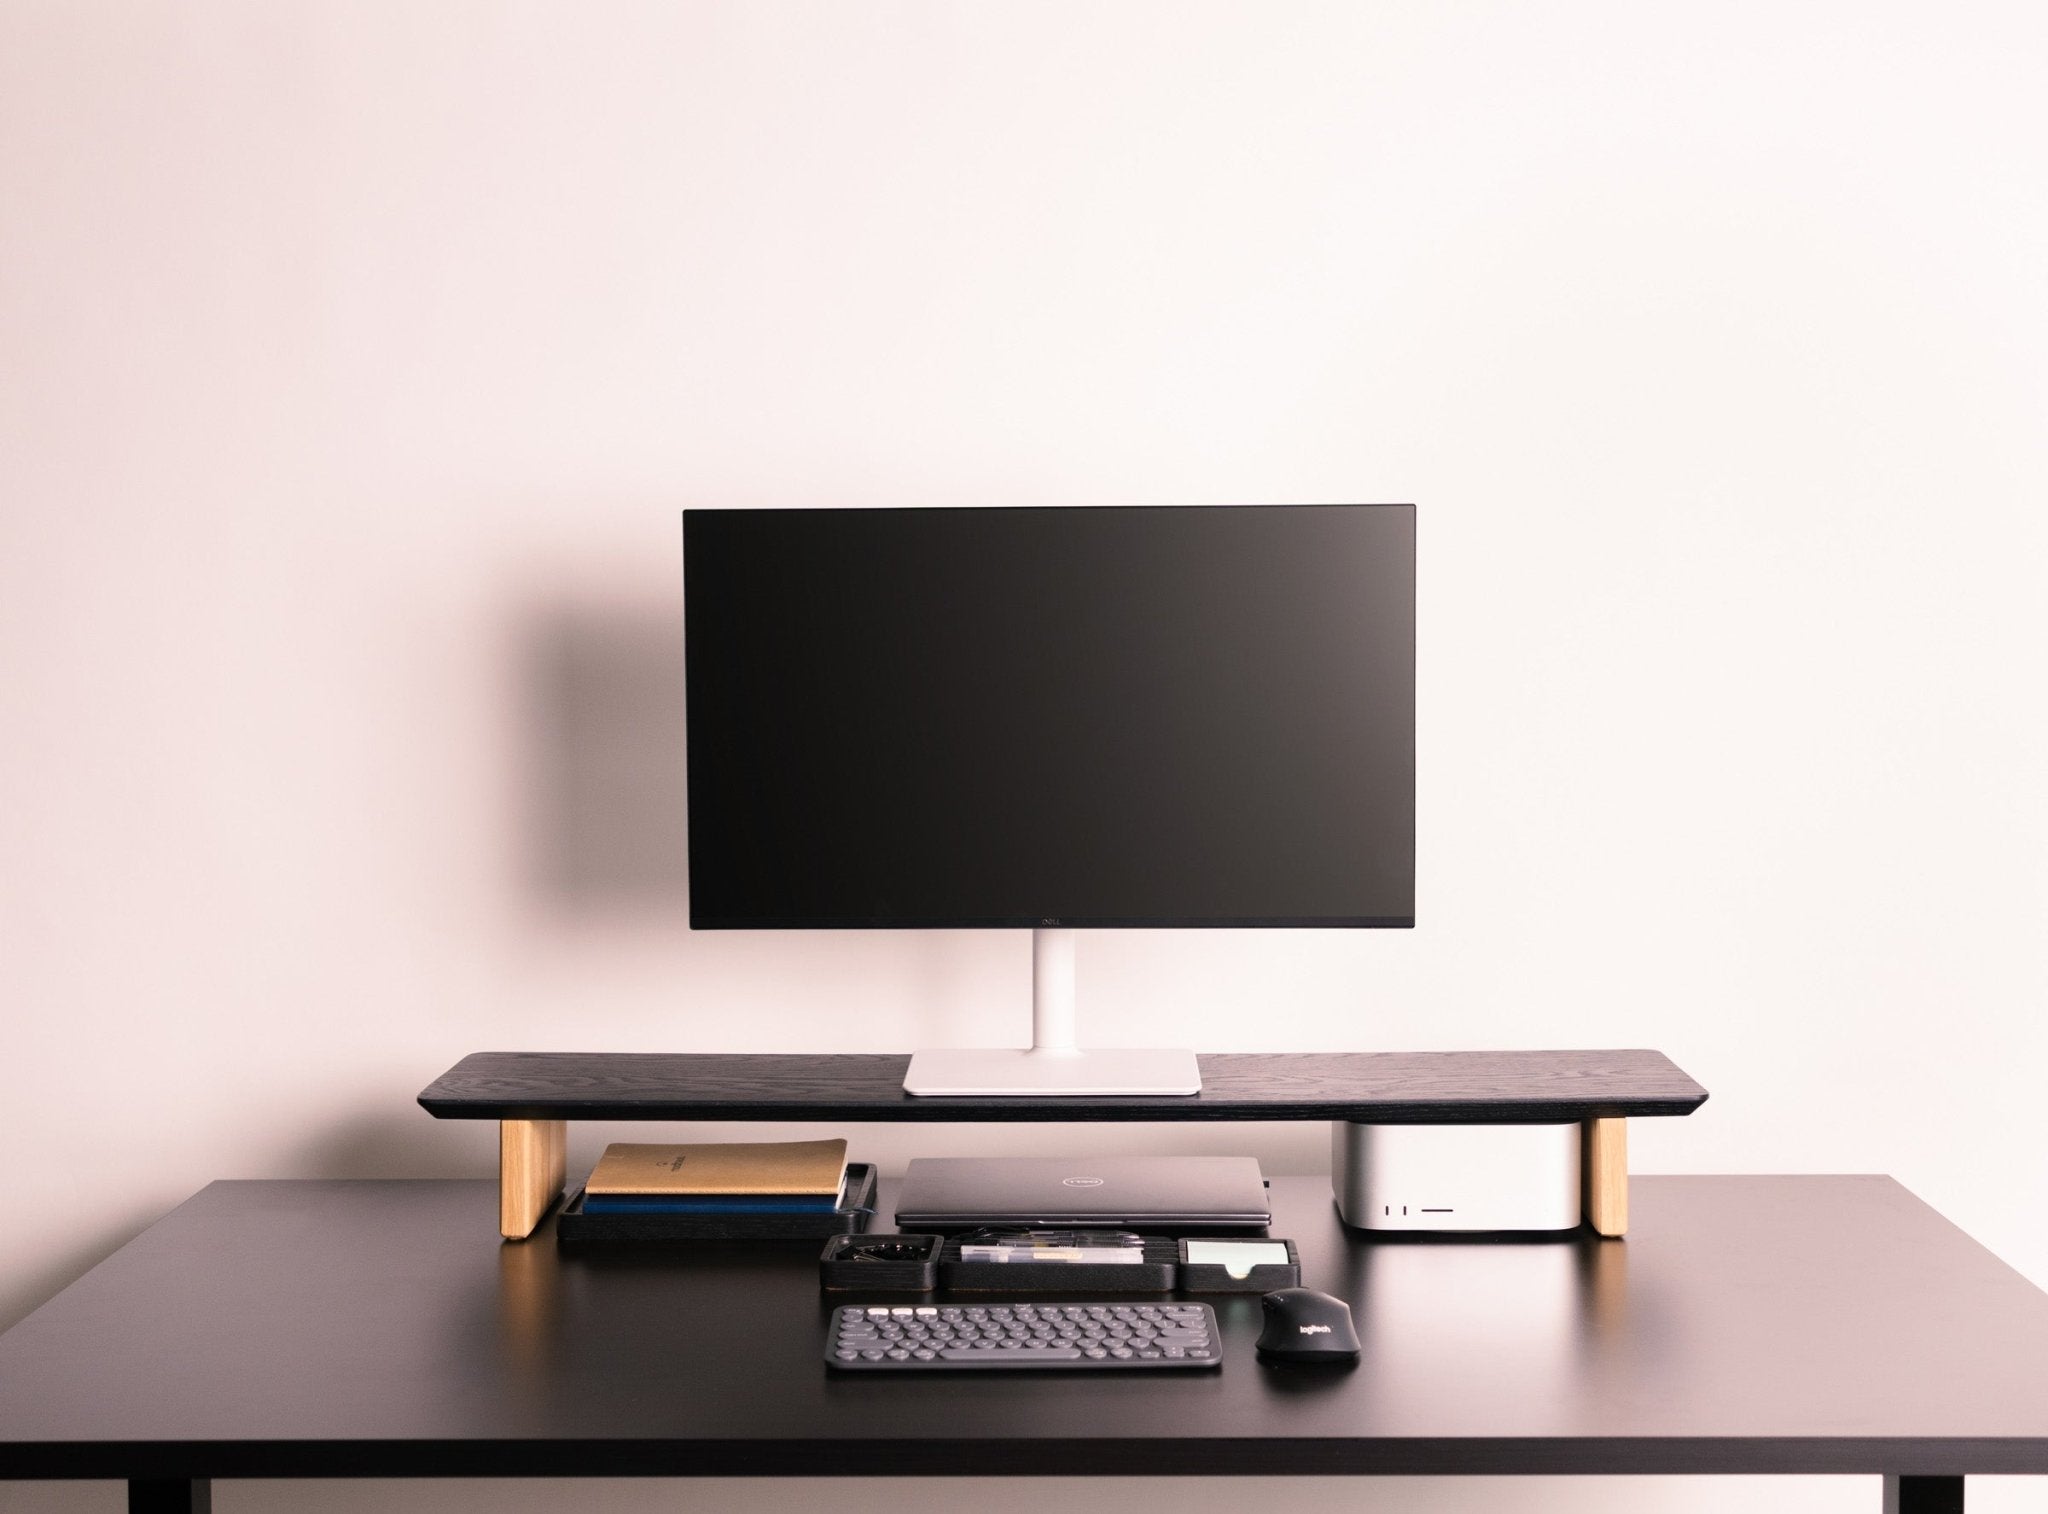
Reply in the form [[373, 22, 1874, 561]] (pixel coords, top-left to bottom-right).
[[518, 606, 690, 916]]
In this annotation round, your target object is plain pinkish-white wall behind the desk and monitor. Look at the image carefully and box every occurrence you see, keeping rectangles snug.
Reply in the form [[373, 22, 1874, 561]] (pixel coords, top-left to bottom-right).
[[0, 0, 2048, 1512]]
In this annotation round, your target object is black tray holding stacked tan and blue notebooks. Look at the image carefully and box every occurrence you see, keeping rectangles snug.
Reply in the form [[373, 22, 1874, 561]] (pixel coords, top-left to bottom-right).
[[561, 1141, 874, 1239]]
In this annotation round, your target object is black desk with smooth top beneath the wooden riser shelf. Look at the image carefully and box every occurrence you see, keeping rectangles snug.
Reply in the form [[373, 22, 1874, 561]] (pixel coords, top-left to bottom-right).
[[0, 1178, 2048, 1510]]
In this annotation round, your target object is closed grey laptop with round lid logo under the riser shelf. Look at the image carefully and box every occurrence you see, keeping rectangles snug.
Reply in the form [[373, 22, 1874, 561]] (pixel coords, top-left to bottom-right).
[[897, 1158, 1272, 1231]]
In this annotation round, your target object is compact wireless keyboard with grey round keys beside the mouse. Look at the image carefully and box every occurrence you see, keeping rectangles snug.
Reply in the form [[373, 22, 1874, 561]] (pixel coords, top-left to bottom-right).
[[825, 1303, 1223, 1373]]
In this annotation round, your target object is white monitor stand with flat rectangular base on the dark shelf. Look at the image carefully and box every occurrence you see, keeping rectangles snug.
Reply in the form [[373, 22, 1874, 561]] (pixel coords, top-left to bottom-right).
[[903, 926, 1202, 1098]]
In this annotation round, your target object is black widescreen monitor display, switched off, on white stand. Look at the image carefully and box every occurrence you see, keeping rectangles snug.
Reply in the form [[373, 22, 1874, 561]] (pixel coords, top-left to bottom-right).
[[684, 504, 1415, 928]]
